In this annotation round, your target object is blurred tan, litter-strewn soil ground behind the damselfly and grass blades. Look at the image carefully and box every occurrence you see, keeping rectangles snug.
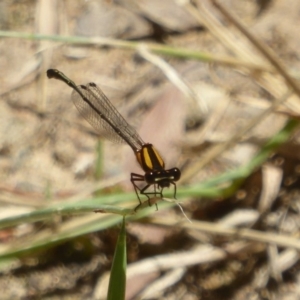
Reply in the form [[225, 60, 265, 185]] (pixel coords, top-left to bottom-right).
[[0, 0, 300, 300]]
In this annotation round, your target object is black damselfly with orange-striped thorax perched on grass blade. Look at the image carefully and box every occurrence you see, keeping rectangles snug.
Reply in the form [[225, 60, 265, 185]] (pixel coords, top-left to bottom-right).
[[47, 69, 181, 209]]
